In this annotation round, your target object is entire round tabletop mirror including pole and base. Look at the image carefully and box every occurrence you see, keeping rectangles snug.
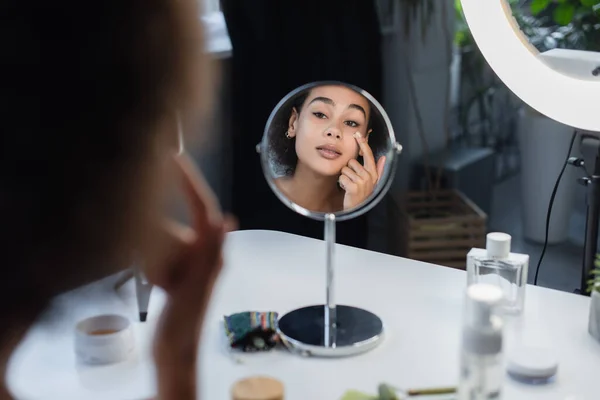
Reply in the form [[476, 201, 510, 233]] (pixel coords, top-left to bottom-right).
[[257, 82, 402, 357]]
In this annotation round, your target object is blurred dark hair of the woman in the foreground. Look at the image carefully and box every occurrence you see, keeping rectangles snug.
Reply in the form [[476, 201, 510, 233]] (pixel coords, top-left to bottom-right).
[[0, 0, 198, 340]]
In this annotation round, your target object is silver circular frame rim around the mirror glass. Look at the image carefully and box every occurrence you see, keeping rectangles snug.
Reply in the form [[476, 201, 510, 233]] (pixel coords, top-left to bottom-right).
[[256, 81, 402, 221]]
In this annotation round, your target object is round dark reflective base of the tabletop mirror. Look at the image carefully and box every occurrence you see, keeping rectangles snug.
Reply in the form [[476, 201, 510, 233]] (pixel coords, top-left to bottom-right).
[[278, 305, 384, 357]]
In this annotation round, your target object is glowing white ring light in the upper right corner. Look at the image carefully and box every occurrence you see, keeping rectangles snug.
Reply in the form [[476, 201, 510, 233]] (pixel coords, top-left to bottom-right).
[[461, 0, 600, 132]]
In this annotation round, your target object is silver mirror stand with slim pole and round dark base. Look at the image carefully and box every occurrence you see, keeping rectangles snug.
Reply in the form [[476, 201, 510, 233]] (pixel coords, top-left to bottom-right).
[[278, 214, 384, 357]]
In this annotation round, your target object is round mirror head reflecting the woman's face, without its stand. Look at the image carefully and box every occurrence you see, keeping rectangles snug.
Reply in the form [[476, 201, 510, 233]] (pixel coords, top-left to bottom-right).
[[258, 82, 402, 221]]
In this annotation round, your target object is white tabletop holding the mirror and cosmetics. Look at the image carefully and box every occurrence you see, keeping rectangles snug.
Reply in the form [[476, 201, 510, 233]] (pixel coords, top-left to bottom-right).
[[9, 231, 600, 400]]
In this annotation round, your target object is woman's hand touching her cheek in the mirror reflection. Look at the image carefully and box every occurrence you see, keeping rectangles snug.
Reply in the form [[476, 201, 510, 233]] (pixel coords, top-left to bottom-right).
[[339, 132, 385, 210]]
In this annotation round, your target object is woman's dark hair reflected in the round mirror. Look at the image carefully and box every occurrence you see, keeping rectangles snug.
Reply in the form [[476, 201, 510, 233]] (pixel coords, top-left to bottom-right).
[[268, 89, 389, 176]]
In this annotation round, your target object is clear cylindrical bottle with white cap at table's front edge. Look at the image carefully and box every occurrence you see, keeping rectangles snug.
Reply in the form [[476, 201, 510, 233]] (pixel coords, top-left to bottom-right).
[[458, 283, 504, 400]]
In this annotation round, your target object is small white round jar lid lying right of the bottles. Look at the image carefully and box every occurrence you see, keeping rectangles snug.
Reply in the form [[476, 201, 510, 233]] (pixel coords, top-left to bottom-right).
[[507, 347, 558, 380]]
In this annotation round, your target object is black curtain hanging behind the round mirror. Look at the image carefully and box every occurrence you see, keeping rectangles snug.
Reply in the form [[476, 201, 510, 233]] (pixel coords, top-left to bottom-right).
[[221, 0, 382, 248]]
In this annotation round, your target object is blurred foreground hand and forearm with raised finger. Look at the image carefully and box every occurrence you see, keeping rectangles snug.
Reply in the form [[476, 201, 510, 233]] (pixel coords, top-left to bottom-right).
[[146, 155, 232, 400]]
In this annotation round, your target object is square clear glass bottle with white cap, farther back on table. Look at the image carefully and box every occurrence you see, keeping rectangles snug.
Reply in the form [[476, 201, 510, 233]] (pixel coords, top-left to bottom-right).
[[467, 232, 529, 314]]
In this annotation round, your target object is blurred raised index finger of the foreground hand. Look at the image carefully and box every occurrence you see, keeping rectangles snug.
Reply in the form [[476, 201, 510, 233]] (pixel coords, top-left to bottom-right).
[[175, 154, 223, 229]]
